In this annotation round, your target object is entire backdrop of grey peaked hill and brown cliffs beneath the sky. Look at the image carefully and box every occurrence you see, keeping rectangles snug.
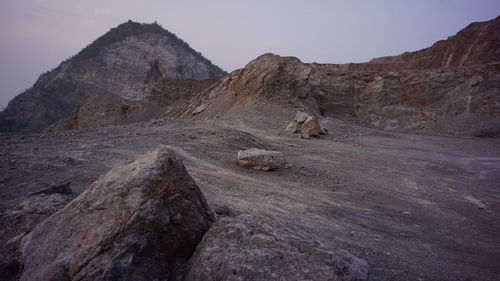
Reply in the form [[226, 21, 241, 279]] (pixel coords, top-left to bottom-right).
[[0, 17, 500, 136]]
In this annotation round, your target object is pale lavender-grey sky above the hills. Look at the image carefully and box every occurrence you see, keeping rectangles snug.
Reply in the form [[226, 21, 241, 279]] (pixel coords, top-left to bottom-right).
[[0, 0, 500, 109]]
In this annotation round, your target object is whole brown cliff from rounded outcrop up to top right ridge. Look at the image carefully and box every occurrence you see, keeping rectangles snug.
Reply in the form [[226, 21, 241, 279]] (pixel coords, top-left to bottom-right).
[[161, 17, 500, 137]]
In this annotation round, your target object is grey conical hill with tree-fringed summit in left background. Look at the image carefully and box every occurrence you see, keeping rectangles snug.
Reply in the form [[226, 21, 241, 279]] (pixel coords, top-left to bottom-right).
[[0, 21, 225, 131]]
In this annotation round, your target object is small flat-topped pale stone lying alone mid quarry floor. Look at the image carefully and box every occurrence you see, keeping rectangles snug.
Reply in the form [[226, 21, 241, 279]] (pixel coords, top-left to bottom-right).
[[236, 148, 285, 171]]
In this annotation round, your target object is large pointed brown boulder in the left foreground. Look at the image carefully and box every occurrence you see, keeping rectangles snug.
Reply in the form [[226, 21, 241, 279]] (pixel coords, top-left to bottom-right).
[[20, 151, 214, 281]]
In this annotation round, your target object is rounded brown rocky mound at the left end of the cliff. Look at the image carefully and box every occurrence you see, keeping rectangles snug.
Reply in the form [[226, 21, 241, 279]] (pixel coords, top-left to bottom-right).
[[169, 54, 317, 119]]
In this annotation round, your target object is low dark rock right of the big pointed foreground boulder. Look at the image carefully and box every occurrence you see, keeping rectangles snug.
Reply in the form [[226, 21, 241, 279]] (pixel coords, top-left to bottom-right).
[[186, 213, 368, 281]]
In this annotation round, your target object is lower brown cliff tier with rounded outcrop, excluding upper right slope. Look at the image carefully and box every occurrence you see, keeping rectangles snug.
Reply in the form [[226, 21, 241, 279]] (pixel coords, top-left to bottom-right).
[[174, 54, 500, 136]]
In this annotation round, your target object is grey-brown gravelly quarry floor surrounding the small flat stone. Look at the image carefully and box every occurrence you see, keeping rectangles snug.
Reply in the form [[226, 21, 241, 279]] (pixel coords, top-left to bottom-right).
[[0, 115, 500, 280]]
